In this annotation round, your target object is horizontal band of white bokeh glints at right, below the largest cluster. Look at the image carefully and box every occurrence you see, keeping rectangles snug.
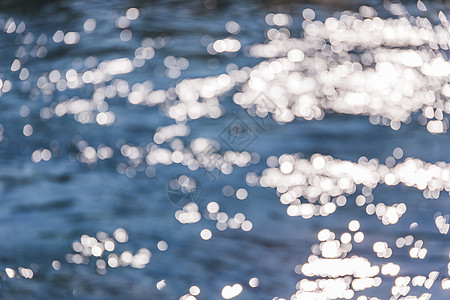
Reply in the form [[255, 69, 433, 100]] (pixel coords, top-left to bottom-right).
[[256, 148, 450, 221]]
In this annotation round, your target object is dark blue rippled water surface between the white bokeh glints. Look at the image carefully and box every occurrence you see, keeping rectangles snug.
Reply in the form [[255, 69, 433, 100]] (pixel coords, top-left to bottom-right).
[[0, 0, 450, 300]]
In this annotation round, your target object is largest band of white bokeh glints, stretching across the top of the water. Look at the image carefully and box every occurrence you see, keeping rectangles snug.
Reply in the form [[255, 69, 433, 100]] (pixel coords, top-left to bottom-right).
[[0, 7, 450, 144]]
